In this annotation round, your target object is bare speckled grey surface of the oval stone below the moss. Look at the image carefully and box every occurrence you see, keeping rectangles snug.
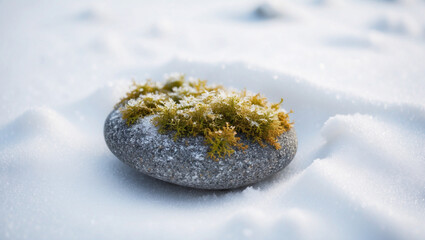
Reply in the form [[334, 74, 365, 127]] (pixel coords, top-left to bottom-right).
[[104, 110, 298, 189]]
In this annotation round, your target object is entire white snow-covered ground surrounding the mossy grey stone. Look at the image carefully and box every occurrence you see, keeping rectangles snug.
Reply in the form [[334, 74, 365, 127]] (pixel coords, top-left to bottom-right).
[[0, 0, 425, 239]]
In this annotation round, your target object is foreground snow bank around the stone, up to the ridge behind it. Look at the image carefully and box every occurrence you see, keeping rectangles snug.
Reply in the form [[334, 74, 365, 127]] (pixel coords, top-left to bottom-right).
[[0, 61, 425, 239]]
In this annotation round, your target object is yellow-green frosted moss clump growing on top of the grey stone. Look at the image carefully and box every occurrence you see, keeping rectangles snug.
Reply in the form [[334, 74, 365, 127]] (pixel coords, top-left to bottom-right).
[[116, 74, 293, 160]]
